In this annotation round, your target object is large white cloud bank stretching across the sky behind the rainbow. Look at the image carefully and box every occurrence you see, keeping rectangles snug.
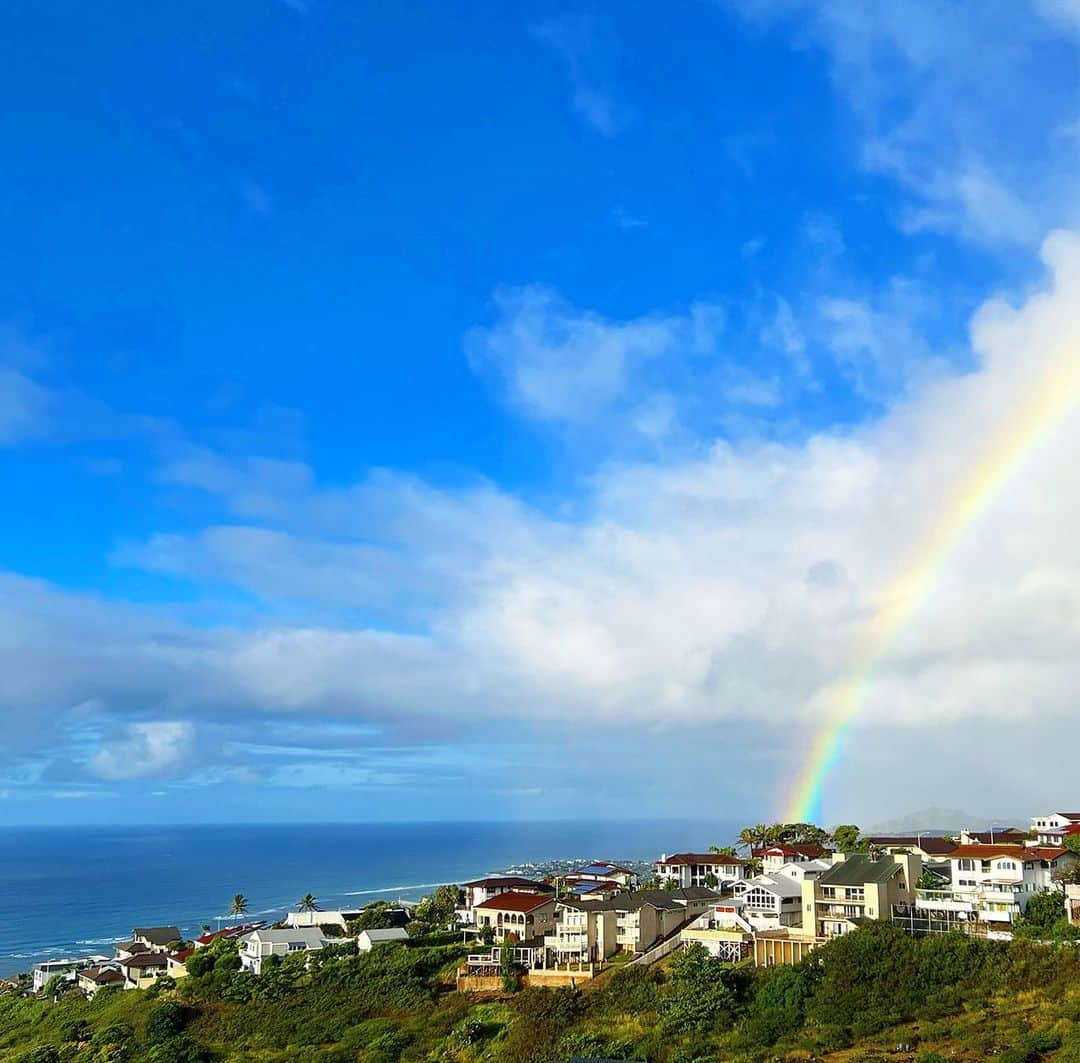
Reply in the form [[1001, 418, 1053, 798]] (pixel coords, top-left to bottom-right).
[[0, 227, 1080, 808]]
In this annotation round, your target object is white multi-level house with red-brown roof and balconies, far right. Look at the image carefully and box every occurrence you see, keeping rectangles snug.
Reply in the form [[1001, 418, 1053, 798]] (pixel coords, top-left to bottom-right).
[[915, 844, 1078, 938]]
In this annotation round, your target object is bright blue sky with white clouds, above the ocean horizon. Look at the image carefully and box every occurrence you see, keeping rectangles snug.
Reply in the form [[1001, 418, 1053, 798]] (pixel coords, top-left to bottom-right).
[[0, 0, 1080, 825]]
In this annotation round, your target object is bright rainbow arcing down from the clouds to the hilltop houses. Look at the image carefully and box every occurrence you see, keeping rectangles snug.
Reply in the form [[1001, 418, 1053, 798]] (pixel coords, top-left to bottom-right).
[[783, 348, 1080, 823]]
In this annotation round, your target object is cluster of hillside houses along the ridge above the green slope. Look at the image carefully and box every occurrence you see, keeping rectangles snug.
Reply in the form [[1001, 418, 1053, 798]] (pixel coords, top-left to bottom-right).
[[25, 812, 1080, 997]]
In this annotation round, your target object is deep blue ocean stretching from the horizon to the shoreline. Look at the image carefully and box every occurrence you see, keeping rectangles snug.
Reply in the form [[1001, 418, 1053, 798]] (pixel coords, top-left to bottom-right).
[[0, 820, 738, 977]]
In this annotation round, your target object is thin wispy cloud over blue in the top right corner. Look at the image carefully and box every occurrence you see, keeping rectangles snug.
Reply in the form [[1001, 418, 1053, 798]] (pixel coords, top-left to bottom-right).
[[733, 0, 1078, 245]]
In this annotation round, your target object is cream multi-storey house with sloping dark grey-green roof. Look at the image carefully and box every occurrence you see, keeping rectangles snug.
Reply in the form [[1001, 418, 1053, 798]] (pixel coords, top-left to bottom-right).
[[802, 852, 922, 938]]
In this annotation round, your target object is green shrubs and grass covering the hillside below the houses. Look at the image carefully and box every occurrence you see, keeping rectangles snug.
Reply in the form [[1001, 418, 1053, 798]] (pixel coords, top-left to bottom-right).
[[0, 924, 1080, 1063]]
